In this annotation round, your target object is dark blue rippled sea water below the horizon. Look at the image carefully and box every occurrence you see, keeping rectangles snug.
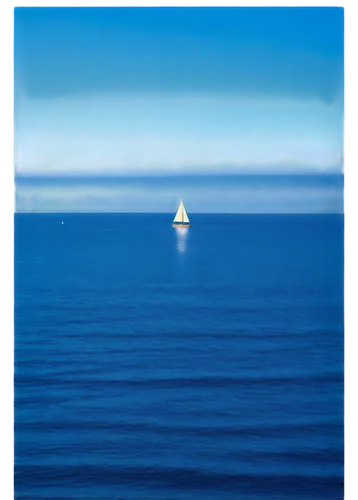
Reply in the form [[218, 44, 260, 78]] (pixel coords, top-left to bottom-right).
[[13, 209, 345, 500]]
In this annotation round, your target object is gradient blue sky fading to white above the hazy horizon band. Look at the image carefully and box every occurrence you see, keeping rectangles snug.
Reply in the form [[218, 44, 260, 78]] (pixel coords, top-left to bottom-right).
[[11, 5, 347, 171]]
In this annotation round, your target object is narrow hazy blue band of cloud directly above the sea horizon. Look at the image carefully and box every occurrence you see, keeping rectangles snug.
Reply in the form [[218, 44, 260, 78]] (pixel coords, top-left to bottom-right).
[[14, 169, 345, 215]]
